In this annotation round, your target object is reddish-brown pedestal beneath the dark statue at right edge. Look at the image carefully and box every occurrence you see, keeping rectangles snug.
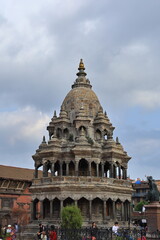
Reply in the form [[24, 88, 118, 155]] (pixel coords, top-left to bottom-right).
[[145, 202, 160, 233]]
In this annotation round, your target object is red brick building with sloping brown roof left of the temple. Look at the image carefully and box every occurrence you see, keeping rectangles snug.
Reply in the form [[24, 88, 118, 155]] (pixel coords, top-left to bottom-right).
[[0, 165, 34, 226]]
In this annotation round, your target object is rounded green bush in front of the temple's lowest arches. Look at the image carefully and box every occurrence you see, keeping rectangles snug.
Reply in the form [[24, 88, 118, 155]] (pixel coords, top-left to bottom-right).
[[61, 205, 82, 229]]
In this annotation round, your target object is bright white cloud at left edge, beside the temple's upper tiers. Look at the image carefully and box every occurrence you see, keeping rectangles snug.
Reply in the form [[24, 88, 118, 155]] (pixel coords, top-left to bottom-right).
[[0, 107, 50, 144]]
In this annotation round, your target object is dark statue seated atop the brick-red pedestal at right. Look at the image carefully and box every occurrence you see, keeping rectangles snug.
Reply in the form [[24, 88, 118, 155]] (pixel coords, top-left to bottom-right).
[[147, 176, 159, 202]]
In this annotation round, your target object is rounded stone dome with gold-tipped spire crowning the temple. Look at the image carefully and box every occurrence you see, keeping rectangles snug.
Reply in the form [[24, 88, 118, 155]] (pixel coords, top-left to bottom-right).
[[62, 60, 101, 120]]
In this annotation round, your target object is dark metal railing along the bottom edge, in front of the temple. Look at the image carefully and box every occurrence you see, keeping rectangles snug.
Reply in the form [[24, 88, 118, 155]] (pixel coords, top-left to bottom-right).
[[22, 228, 160, 240]]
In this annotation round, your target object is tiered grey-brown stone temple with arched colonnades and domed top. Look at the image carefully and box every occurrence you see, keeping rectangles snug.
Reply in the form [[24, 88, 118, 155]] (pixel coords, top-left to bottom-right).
[[30, 60, 132, 226]]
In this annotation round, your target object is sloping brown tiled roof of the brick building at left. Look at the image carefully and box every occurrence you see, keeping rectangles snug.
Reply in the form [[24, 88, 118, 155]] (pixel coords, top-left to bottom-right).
[[0, 165, 42, 181]]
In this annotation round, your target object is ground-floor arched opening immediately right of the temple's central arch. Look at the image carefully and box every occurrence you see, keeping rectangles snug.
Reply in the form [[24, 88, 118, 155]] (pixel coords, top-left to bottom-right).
[[92, 198, 103, 221]]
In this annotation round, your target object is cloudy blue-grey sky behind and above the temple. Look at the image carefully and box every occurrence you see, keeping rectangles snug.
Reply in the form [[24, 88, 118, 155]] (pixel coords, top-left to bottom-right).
[[0, 0, 160, 179]]
